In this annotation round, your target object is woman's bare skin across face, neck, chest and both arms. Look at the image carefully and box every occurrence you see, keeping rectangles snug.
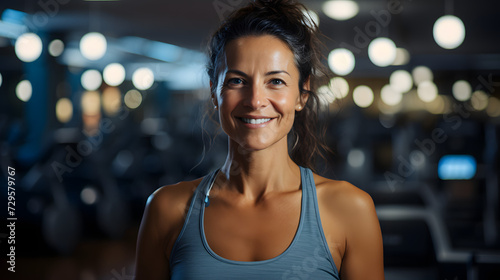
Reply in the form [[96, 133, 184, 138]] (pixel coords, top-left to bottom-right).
[[136, 35, 384, 280]]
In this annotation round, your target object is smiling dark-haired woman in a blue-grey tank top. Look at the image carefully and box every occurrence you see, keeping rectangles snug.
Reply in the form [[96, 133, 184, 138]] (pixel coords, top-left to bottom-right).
[[136, 0, 384, 280]]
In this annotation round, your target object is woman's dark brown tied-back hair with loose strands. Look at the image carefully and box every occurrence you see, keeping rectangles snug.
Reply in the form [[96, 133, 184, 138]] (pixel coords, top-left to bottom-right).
[[203, 0, 330, 170]]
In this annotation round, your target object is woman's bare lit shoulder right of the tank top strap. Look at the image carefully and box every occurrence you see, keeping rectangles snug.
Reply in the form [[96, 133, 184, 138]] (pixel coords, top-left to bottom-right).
[[314, 174, 374, 214]]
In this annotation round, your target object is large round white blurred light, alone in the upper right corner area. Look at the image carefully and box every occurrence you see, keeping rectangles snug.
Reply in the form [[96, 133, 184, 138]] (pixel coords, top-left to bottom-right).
[[432, 15, 465, 49]]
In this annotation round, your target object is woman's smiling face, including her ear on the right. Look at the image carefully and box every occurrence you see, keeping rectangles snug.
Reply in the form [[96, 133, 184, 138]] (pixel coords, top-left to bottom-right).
[[214, 35, 309, 150]]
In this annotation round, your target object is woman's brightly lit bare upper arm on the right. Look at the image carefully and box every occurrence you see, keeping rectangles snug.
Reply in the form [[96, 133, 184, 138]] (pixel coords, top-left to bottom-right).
[[340, 187, 384, 280]]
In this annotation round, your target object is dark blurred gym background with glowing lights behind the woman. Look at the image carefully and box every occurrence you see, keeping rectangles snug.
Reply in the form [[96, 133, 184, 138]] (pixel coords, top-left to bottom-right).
[[0, 0, 500, 280]]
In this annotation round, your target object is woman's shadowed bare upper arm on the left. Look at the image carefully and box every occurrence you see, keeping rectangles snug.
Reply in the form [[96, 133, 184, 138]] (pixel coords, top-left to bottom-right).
[[135, 191, 170, 280]]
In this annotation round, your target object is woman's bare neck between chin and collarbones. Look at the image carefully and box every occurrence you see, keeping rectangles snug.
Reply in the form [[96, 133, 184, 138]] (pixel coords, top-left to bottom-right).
[[221, 138, 300, 202]]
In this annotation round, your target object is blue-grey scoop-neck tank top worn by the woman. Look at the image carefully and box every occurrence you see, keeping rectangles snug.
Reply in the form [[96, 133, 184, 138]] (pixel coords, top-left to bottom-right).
[[170, 166, 339, 280]]
